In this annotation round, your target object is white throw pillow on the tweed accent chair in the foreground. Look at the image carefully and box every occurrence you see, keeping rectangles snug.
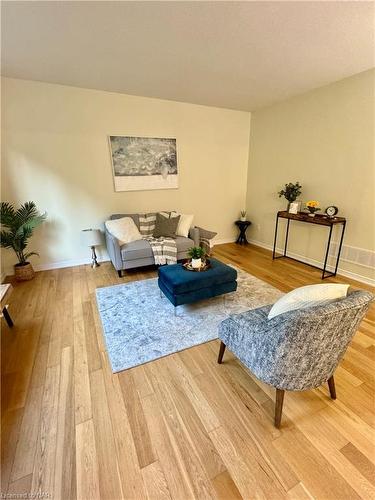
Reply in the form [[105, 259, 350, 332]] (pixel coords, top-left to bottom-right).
[[268, 283, 349, 319]]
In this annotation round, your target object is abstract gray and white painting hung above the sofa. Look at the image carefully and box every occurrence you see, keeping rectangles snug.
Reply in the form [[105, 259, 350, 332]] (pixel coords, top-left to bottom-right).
[[109, 135, 178, 191]]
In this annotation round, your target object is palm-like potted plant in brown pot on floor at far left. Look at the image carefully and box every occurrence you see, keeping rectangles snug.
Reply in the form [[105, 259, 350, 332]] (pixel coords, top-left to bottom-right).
[[0, 201, 47, 281]]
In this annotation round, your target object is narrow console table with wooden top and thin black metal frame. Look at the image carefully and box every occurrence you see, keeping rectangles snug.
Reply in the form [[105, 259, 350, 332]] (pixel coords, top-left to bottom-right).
[[272, 211, 346, 279]]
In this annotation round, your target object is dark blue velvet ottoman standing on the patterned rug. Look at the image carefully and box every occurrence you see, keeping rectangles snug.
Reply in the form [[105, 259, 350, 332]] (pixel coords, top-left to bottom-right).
[[158, 259, 237, 307]]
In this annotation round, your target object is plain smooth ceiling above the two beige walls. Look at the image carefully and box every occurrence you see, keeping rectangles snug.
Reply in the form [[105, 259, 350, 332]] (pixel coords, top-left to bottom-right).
[[2, 1, 375, 110]]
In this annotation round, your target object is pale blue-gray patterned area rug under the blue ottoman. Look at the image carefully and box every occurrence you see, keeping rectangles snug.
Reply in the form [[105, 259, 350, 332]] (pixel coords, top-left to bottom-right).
[[96, 269, 282, 372]]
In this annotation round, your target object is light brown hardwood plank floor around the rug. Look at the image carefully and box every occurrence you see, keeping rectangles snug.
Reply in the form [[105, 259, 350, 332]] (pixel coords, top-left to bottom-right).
[[1, 244, 375, 500]]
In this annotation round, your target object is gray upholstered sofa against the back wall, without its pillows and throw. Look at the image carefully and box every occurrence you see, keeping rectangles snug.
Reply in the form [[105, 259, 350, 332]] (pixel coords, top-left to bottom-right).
[[105, 214, 200, 277]]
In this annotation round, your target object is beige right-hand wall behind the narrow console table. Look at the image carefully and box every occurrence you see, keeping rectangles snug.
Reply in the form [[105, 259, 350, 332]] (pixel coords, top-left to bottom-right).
[[247, 70, 375, 279]]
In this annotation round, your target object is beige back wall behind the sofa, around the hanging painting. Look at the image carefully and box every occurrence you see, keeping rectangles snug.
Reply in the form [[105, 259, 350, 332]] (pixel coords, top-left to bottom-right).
[[2, 79, 250, 272]]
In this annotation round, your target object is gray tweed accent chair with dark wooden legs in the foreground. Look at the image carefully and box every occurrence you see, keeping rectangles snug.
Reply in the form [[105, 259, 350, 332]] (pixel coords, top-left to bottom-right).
[[218, 290, 374, 428]]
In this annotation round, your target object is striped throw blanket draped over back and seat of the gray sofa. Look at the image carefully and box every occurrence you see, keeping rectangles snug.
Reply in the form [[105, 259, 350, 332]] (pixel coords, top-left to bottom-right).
[[139, 212, 177, 266]]
